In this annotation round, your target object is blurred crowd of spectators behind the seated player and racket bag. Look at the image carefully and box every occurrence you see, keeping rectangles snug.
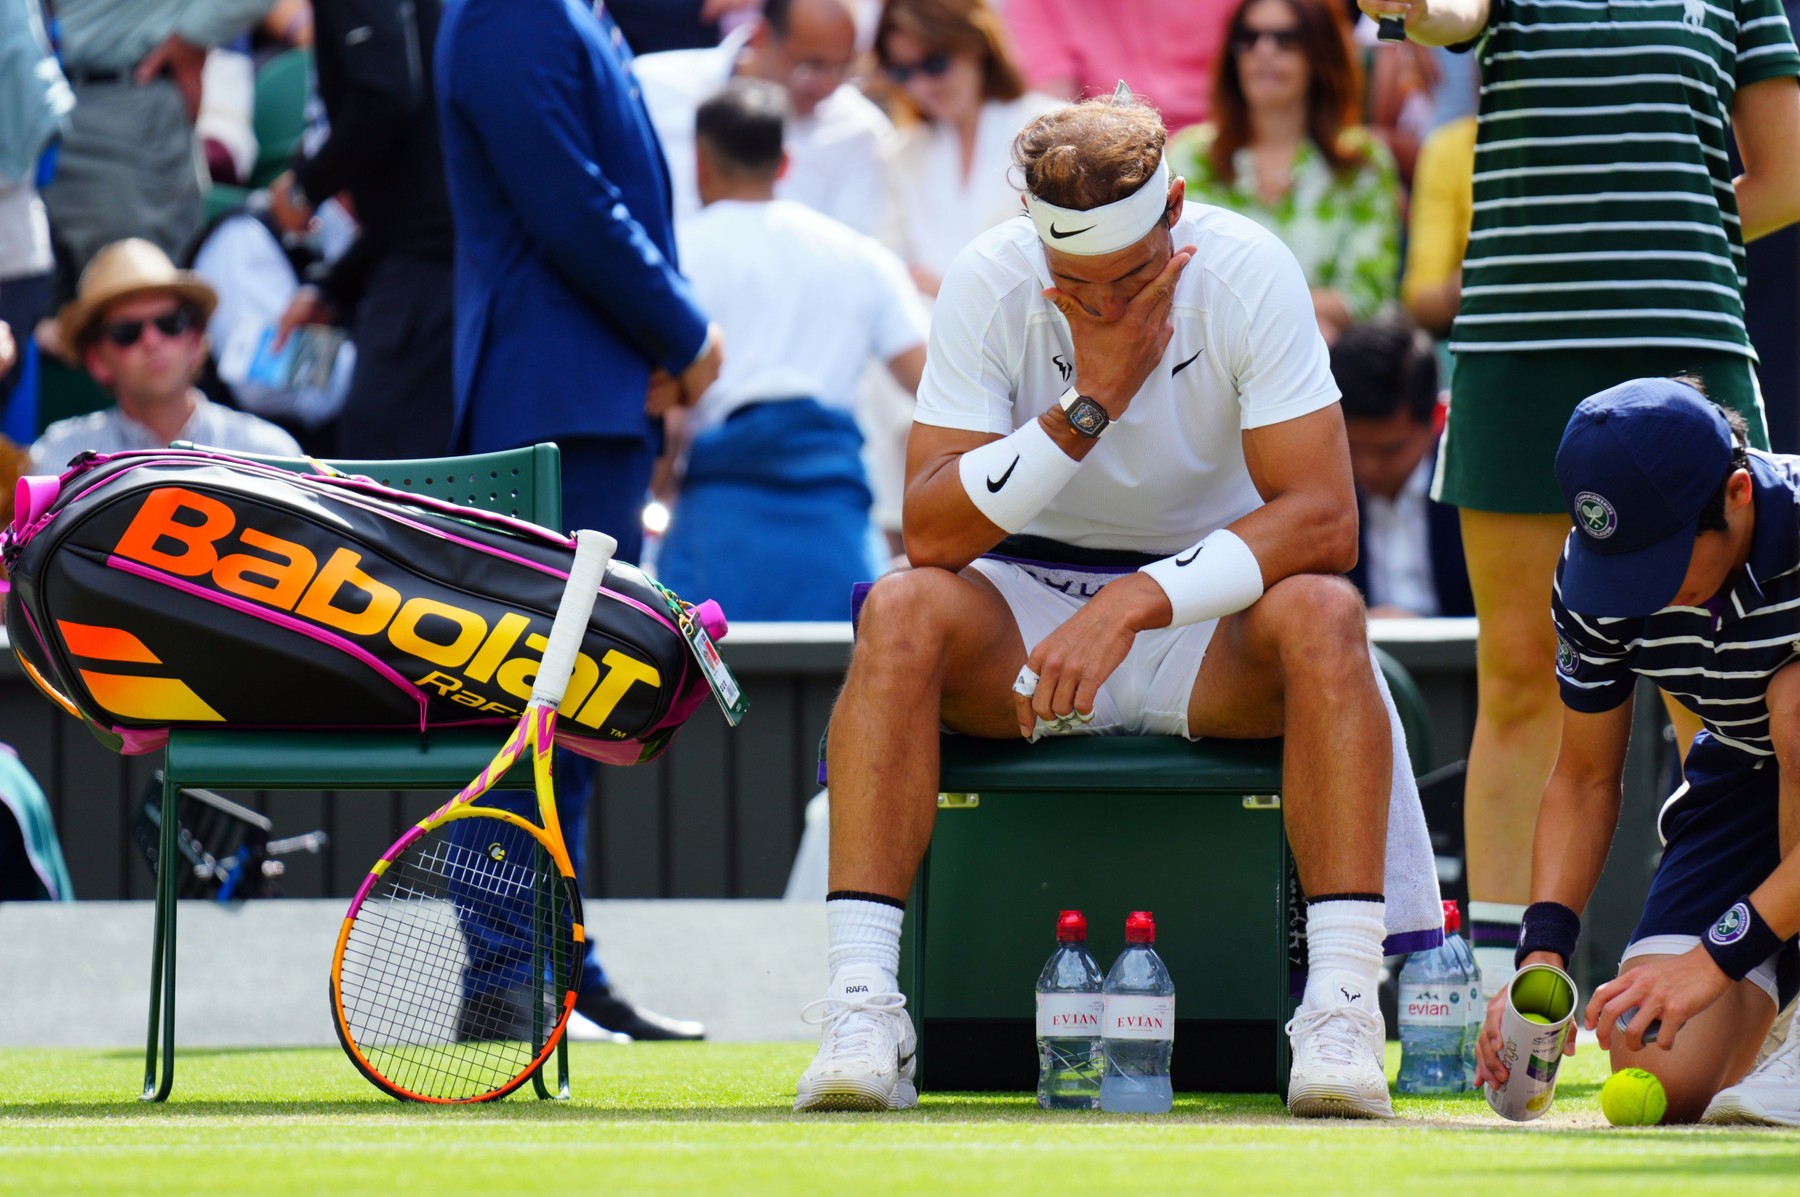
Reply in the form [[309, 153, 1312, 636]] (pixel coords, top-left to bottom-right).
[[0, 0, 1785, 619]]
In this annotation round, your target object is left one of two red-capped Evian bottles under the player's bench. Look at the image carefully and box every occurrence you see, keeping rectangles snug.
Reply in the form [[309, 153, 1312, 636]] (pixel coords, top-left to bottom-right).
[[1037, 911, 1105, 1111]]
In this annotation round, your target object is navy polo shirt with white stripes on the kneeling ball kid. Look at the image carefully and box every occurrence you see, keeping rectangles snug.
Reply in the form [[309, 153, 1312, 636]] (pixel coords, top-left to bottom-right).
[[1550, 450, 1800, 763]]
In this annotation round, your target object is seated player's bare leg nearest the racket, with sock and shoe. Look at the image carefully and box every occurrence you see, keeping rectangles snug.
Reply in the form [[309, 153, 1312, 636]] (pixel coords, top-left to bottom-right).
[[794, 569, 1024, 1111]]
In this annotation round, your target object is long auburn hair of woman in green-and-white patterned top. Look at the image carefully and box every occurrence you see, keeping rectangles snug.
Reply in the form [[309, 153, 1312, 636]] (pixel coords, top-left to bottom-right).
[[1208, 0, 1366, 184]]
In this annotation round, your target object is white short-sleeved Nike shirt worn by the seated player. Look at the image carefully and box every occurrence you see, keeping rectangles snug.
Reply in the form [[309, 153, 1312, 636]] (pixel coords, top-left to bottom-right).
[[914, 203, 1337, 554]]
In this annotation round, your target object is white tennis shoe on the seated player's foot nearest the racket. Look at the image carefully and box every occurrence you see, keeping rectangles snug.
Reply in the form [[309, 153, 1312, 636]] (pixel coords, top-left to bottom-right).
[[794, 968, 918, 1111]]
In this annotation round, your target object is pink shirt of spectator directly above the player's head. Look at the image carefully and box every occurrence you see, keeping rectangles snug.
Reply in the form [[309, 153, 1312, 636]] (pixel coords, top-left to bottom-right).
[[1003, 0, 1228, 133]]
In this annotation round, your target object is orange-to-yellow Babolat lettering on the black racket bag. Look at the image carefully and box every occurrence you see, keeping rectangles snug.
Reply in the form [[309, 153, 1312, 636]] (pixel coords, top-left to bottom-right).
[[113, 486, 662, 736]]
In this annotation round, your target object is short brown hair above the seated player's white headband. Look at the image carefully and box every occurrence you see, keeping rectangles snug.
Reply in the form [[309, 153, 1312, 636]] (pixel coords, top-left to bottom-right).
[[1013, 97, 1168, 211]]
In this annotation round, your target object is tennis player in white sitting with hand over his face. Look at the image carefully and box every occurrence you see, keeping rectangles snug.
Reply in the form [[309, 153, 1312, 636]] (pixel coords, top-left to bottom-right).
[[794, 92, 1442, 1118]]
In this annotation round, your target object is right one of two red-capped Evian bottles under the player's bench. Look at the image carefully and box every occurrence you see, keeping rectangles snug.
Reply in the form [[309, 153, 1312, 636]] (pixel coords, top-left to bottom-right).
[[1100, 911, 1175, 1114]]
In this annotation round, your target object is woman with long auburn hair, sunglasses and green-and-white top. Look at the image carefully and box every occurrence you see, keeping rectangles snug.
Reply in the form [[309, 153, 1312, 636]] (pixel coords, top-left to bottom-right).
[[1168, 0, 1400, 342]]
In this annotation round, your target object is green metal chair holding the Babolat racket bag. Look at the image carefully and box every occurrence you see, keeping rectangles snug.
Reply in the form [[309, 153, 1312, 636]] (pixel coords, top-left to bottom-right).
[[142, 445, 569, 1102]]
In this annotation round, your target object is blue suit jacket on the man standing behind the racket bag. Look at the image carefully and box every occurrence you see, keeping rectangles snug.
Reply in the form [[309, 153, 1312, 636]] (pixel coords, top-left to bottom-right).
[[436, 0, 706, 452]]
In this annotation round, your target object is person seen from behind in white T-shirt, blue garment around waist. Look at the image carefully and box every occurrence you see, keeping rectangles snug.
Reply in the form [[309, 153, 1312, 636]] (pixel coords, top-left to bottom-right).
[[657, 79, 925, 619]]
